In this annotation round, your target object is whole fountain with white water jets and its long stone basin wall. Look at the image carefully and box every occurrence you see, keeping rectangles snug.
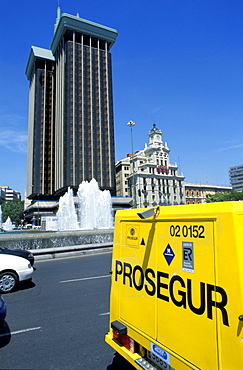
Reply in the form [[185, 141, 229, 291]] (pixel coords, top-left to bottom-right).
[[0, 180, 113, 251]]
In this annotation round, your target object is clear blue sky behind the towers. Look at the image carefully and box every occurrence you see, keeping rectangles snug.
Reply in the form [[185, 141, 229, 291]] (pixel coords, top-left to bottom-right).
[[0, 0, 243, 194]]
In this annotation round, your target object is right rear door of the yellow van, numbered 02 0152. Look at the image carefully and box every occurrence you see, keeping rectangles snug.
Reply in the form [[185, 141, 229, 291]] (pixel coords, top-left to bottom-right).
[[156, 218, 217, 369]]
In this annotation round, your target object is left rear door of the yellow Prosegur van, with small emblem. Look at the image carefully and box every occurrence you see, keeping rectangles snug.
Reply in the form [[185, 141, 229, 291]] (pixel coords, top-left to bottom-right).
[[118, 222, 156, 337]]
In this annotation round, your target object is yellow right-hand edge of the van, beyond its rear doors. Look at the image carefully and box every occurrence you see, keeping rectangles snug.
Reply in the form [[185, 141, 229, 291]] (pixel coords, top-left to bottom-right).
[[216, 211, 243, 370]]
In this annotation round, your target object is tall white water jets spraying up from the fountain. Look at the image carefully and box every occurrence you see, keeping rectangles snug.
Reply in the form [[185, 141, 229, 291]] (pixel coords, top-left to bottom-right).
[[57, 179, 113, 230]]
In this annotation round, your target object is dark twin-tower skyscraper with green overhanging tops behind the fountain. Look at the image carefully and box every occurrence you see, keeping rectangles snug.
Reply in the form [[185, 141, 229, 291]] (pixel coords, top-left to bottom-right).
[[26, 8, 117, 198]]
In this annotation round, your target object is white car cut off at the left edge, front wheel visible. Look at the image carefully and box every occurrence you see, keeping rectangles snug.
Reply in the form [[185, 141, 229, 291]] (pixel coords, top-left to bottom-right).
[[0, 254, 34, 294]]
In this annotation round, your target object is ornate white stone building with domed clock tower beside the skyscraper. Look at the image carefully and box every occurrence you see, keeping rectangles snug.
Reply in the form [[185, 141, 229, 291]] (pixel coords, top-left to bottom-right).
[[116, 124, 185, 208]]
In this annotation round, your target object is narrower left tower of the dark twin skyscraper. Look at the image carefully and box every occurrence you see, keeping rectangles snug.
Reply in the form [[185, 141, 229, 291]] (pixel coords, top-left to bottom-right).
[[27, 46, 55, 196]]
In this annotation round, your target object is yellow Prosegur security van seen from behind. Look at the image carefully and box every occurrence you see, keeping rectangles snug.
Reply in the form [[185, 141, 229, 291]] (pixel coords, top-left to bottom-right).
[[105, 202, 243, 370]]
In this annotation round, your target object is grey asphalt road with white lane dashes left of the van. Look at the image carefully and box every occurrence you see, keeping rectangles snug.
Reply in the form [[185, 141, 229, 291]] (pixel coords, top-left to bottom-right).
[[0, 253, 133, 370]]
